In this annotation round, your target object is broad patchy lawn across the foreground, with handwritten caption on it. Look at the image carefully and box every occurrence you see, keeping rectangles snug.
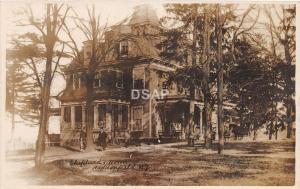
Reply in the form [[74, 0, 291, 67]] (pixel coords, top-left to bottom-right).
[[4, 141, 295, 186]]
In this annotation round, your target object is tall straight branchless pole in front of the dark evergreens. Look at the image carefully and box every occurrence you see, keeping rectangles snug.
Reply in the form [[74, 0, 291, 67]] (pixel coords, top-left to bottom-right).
[[216, 3, 224, 154]]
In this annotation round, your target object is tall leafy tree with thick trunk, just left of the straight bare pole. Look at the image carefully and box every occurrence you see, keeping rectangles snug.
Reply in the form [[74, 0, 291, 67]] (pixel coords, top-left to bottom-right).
[[161, 4, 251, 147]]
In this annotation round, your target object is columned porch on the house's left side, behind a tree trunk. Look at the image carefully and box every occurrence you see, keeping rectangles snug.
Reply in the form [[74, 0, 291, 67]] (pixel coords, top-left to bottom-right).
[[60, 100, 130, 147]]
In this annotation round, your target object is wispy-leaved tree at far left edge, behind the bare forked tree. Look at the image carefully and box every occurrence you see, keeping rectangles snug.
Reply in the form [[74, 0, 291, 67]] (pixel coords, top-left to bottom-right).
[[6, 36, 43, 130]]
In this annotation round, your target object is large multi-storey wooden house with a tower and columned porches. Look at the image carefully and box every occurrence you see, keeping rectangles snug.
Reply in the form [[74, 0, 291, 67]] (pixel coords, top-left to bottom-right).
[[60, 5, 213, 146]]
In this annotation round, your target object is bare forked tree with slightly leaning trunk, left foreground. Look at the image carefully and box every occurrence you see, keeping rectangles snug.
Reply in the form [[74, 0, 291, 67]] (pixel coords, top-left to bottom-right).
[[13, 4, 69, 168]]
